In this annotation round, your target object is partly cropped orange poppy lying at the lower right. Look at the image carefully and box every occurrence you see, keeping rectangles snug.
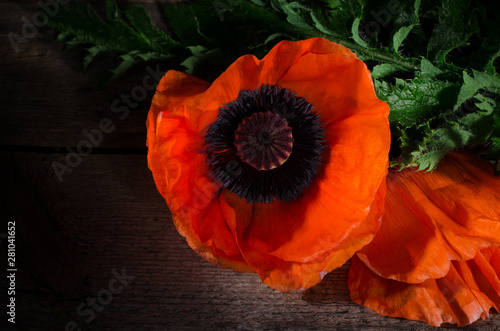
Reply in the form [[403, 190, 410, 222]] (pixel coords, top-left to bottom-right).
[[348, 153, 500, 326]]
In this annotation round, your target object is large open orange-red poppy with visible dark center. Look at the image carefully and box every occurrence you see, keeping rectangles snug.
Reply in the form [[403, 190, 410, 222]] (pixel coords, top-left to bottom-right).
[[147, 38, 390, 291]]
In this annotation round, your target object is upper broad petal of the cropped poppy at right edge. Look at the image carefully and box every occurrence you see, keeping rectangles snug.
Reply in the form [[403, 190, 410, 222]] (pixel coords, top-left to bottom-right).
[[358, 153, 500, 283]]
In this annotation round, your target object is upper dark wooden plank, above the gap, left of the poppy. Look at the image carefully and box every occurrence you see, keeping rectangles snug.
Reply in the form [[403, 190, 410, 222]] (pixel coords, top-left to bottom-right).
[[0, 2, 171, 150]]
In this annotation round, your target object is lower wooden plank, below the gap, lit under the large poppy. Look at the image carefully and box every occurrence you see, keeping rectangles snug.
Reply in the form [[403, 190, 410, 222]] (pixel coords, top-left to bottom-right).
[[0, 153, 500, 330]]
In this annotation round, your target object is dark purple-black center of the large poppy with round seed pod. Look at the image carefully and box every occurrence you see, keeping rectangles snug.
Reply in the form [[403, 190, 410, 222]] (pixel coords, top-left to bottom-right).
[[205, 85, 324, 203]]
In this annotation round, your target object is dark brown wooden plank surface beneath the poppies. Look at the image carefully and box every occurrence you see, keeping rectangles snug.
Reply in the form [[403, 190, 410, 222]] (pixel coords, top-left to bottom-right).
[[0, 1, 500, 330]]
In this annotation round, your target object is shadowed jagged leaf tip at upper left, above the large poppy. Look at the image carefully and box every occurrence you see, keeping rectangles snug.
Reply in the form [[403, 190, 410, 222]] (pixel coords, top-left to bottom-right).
[[44, 0, 185, 80]]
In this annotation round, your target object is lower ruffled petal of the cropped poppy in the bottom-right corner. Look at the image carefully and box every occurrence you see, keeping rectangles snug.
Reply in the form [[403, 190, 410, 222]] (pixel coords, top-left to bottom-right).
[[348, 247, 500, 326]]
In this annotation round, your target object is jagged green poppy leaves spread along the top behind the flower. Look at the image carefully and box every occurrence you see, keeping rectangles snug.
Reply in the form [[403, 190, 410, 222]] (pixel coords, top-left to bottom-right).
[[45, 0, 500, 170]]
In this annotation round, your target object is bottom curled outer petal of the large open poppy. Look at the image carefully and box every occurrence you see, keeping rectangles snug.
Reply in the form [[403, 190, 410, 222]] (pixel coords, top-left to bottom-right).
[[222, 184, 385, 292]]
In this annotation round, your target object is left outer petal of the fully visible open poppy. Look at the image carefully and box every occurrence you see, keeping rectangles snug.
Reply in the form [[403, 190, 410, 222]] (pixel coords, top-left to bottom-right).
[[147, 71, 251, 271]]
